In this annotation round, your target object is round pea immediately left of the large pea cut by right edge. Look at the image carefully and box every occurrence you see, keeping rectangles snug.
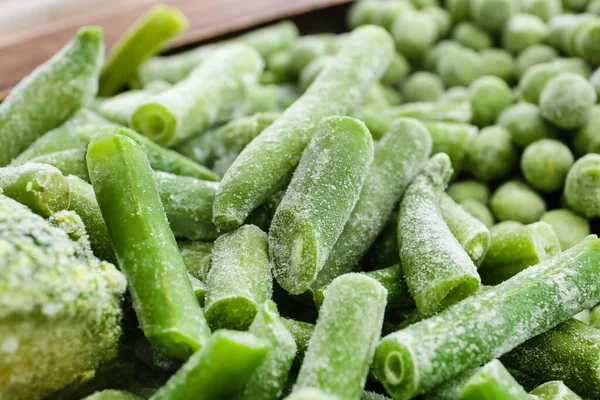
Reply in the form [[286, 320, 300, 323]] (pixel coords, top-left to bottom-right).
[[521, 139, 574, 192]]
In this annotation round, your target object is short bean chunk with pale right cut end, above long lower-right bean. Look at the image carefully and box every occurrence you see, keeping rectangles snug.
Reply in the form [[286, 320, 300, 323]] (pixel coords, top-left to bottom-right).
[[479, 222, 561, 285]]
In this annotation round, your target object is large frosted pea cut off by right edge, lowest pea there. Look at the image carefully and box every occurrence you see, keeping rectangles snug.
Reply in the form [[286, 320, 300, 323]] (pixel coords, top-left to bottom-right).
[[565, 154, 600, 218]]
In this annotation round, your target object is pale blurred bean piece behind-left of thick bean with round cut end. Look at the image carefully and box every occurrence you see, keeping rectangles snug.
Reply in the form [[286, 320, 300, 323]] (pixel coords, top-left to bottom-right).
[[94, 81, 171, 126]]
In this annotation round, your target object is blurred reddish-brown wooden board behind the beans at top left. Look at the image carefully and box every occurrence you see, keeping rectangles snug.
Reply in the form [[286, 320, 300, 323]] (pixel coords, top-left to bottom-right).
[[0, 0, 351, 99]]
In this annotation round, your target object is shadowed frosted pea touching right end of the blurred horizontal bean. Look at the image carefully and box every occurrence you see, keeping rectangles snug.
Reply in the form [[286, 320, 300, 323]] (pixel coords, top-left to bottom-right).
[[465, 125, 517, 182]]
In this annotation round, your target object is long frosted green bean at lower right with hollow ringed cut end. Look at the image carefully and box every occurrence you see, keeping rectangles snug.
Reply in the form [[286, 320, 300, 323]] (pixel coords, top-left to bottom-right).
[[373, 235, 600, 398]]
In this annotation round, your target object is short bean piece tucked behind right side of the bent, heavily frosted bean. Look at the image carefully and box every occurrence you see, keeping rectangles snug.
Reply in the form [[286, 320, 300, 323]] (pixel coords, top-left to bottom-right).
[[440, 194, 490, 266]]
